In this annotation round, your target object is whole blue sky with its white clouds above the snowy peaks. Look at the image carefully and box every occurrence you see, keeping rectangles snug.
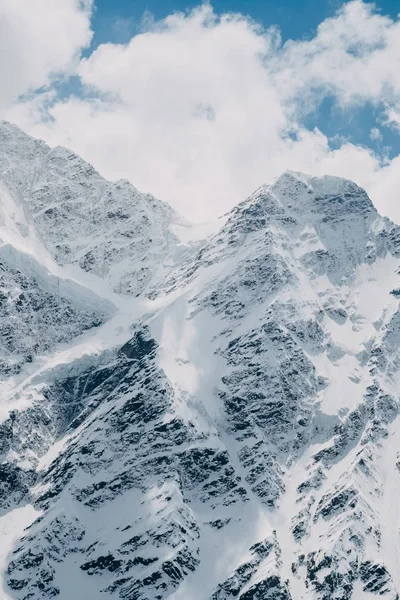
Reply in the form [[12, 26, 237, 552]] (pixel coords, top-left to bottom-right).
[[4, 0, 400, 221]]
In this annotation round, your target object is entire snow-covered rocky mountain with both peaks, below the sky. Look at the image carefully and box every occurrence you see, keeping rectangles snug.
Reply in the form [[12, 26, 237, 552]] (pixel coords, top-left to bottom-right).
[[0, 123, 400, 600]]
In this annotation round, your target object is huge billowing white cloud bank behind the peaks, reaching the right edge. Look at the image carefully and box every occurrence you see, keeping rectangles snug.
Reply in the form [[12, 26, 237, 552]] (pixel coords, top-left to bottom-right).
[[0, 0, 400, 221]]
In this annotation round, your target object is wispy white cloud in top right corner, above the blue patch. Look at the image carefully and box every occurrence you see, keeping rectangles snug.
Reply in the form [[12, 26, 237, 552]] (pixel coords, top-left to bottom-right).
[[275, 0, 400, 106]]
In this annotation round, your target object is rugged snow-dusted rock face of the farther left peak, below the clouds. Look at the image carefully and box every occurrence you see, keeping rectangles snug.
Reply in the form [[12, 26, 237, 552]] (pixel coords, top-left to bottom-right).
[[0, 122, 200, 296]]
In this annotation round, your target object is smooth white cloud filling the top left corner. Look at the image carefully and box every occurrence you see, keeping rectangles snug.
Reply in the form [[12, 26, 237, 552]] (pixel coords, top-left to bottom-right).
[[0, 0, 92, 109]]
